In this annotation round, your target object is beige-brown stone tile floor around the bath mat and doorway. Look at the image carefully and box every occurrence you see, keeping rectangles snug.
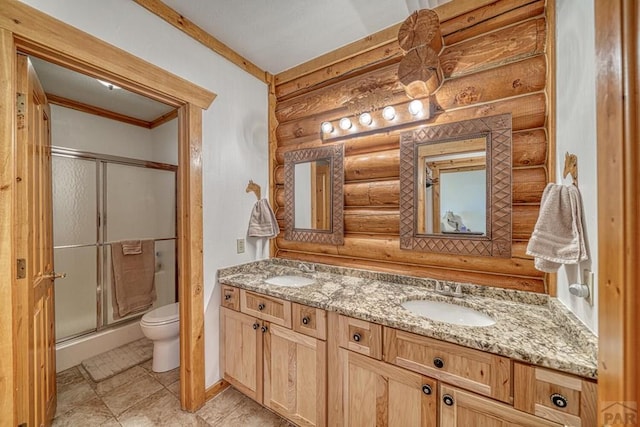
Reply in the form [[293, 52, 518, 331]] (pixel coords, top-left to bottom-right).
[[53, 360, 293, 427]]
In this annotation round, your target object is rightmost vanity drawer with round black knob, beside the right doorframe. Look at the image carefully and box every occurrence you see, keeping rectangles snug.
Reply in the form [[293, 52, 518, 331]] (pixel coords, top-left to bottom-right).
[[513, 362, 597, 427]]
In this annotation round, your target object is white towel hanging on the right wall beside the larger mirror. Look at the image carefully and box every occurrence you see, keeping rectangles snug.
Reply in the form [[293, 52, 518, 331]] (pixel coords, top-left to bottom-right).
[[527, 184, 589, 273]]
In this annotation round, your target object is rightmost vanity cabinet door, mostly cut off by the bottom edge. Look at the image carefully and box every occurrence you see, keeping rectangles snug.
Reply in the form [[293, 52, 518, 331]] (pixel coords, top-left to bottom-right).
[[440, 384, 561, 427]]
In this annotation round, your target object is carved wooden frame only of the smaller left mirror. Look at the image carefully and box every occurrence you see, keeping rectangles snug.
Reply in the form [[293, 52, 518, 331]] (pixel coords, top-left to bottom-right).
[[284, 144, 344, 245]]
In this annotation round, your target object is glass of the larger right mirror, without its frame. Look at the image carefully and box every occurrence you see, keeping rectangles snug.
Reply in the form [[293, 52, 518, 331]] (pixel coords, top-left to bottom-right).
[[416, 136, 487, 236]]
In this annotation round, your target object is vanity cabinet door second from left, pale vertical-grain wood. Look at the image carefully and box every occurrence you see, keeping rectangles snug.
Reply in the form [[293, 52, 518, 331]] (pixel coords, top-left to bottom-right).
[[264, 324, 327, 427]]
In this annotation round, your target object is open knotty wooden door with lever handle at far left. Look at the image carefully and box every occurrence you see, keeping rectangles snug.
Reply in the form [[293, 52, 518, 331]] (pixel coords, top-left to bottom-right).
[[16, 54, 58, 426]]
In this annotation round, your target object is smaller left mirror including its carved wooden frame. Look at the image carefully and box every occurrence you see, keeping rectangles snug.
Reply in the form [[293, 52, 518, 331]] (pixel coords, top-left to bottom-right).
[[284, 144, 344, 245]]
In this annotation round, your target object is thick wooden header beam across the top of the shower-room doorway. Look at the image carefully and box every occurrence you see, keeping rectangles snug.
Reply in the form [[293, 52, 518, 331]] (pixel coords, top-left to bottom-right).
[[0, 0, 216, 109]]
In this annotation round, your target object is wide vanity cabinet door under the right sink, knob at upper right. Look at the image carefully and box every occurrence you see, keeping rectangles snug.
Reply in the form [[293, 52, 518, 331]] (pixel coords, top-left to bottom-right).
[[340, 349, 438, 427]]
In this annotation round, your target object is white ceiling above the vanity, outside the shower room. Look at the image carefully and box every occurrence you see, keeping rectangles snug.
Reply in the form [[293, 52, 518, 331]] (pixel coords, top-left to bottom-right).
[[163, 0, 450, 74]]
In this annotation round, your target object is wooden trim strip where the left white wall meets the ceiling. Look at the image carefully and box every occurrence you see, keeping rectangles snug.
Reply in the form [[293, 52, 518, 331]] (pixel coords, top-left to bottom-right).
[[133, 0, 268, 83]]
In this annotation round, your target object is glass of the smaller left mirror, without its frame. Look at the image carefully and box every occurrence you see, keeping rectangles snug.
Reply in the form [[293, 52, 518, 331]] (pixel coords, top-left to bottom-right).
[[293, 159, 331, 231]]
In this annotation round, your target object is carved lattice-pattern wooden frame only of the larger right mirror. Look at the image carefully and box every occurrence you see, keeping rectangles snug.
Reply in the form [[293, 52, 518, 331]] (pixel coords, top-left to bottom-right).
[[400, 114, 511, 258]]
